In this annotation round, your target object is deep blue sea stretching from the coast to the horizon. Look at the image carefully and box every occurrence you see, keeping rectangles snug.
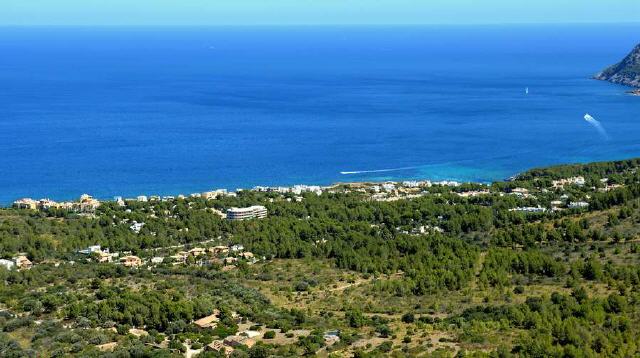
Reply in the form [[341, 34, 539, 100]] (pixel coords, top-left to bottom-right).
[[0, 25, 640, 204]]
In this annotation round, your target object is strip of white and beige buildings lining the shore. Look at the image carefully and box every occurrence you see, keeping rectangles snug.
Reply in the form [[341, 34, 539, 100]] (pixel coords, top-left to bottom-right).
[[13, 176, 608, 224]]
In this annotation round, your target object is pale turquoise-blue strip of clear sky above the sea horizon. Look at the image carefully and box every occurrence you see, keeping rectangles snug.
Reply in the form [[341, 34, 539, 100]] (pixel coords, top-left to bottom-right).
[[0, 0, 640, 26]]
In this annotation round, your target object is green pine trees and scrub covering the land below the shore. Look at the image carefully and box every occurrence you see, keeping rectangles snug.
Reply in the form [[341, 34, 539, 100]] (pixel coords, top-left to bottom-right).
[[0, 159, 640, 357]]
